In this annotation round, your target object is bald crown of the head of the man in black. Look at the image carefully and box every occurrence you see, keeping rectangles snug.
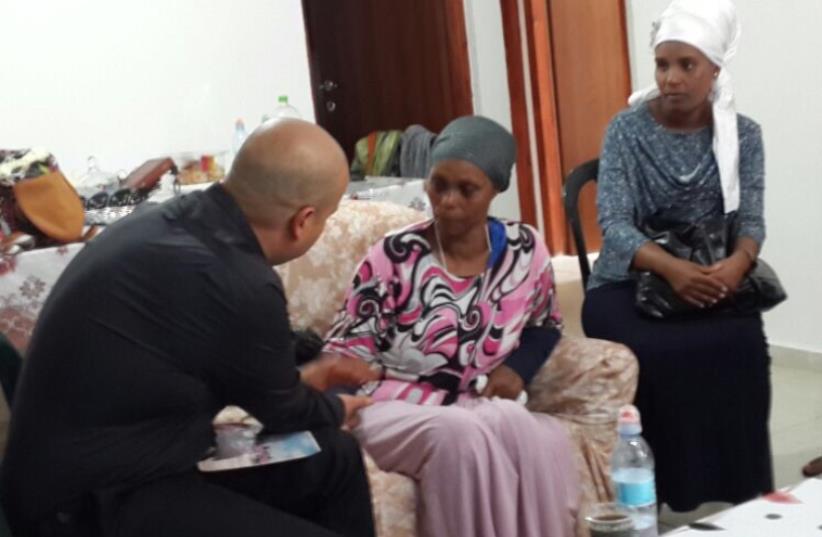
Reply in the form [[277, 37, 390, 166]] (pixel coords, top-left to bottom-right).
[[223, 119, 348, 226]]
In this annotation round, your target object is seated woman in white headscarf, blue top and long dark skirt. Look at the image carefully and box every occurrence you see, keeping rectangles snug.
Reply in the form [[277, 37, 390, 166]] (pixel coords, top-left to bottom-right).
[[583, 0, 773, 511]]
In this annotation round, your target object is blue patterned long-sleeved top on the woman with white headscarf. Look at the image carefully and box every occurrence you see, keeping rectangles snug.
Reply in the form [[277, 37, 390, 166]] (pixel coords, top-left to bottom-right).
[[588, 103, 765, 289]]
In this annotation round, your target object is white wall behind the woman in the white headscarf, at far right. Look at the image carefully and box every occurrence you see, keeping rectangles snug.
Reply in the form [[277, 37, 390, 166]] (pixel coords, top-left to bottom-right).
[[628, 0, 822, 352]]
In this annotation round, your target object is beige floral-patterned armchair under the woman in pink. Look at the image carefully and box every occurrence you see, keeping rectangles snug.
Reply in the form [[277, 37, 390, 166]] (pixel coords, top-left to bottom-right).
[[278, 200, 638, 537]]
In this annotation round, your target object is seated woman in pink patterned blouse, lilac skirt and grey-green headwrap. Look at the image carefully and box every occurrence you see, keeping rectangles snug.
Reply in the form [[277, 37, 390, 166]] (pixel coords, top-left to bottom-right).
[[325, 117, 580, 537]]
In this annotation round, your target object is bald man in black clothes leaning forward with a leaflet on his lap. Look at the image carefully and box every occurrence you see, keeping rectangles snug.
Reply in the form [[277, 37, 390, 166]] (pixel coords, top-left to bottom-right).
[[0, 121, 374, 537]]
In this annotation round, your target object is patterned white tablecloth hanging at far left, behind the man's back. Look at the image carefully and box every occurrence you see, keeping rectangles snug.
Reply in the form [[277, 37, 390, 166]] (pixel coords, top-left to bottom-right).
[[0, 243, 84, 351]]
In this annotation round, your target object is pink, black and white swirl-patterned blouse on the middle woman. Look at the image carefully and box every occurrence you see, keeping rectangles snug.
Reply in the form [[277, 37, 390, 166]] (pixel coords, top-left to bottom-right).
[[325, 220, 561, 404]]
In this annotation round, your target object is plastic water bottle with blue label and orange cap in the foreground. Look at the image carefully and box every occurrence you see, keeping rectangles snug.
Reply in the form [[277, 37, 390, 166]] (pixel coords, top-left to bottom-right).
[[611, 405, 657, 537]]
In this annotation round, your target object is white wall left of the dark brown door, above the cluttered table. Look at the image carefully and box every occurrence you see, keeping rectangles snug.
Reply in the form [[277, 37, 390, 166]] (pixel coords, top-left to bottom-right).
[[0, 0, 314, 180]]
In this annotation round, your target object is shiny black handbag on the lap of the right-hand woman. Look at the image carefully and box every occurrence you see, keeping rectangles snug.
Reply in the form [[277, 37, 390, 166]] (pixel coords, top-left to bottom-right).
[[636, 212, 787, 319]]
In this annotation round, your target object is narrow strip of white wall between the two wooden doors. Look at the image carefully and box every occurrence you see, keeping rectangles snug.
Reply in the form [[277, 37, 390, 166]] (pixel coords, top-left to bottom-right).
[[464, 0, 520, 220]]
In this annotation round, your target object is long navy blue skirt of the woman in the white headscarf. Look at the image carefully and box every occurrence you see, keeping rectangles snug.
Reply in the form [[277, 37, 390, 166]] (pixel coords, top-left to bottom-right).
[[582, 282, 773, 511]]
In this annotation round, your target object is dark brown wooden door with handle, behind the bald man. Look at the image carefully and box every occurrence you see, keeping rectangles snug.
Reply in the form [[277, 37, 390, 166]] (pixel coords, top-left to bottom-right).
[[303, 0, 473, 157]]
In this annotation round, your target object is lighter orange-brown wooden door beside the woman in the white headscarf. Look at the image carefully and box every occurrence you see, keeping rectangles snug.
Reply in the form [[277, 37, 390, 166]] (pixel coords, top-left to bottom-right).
[[549, 0, 631, 252]]
